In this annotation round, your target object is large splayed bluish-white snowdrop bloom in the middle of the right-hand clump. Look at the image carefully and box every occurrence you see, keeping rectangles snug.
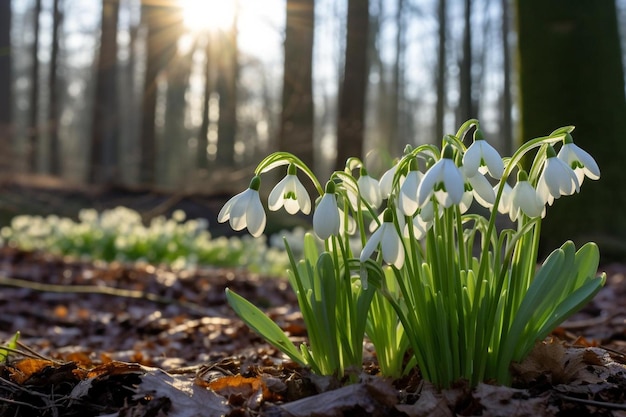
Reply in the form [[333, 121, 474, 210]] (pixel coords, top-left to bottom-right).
[[417, 146, 465, 208]]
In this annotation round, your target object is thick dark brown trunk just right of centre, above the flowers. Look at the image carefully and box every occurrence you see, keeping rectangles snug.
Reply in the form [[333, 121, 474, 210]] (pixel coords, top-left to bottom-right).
[[335, 0, 369, 170]]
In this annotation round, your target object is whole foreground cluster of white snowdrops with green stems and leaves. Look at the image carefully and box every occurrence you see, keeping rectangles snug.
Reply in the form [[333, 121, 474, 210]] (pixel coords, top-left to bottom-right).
[[218, 120, 604, 386]]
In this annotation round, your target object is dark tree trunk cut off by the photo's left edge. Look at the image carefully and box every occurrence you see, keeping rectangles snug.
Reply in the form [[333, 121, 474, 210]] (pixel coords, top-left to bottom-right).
[[0, 0, 13, 172]]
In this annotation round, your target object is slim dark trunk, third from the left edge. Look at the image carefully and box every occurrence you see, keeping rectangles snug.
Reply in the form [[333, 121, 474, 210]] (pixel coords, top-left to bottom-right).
[[48, 0, 62, 176]]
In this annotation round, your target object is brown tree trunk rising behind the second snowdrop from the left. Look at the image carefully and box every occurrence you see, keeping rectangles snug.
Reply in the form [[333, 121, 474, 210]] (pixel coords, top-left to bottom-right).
[[278, 0, 315, 168]]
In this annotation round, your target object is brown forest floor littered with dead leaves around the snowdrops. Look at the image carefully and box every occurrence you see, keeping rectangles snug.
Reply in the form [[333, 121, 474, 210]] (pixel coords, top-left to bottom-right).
[[0, 248, 626, 417]]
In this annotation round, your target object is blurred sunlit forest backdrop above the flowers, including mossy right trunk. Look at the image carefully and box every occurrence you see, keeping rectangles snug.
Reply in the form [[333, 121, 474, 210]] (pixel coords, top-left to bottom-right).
[[0, 0, 626, 256]]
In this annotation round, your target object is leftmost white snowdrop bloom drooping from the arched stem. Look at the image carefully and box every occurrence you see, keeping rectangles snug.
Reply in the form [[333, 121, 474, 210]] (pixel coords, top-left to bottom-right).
[[217, 176, 265, 237]]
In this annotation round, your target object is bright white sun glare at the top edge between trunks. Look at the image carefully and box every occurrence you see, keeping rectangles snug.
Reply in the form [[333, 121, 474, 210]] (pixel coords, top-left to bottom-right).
[[180, 0, 237, 31]]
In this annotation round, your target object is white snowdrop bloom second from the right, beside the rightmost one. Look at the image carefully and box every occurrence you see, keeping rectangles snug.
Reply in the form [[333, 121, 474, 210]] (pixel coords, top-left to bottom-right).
[[537, 146, 580, 205]]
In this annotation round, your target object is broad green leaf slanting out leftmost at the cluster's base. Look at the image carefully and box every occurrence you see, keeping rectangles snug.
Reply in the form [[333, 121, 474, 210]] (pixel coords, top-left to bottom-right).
[[226, 288, 306, 366]]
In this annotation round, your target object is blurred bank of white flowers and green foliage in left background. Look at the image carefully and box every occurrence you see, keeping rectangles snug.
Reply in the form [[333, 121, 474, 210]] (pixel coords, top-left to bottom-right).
[[2, 207, 288, 276]]
